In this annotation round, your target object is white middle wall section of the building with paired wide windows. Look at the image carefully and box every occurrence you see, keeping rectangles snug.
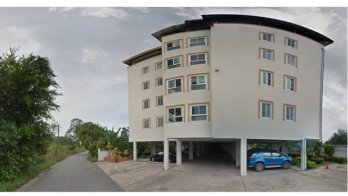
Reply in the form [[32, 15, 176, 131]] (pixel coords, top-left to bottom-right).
[[162, 30, 212, 138]]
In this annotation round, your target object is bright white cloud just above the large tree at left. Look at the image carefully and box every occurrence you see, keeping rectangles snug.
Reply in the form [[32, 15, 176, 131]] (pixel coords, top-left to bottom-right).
[[0, 25, 42, 55]]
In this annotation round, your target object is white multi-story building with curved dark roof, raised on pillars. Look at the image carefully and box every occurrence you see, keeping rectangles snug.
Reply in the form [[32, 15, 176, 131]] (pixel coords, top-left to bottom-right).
[[124, 15, 333, 175]]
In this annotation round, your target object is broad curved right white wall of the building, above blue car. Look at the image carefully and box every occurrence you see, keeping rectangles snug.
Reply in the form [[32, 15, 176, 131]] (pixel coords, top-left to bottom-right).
[[211, 24, 322, 140]]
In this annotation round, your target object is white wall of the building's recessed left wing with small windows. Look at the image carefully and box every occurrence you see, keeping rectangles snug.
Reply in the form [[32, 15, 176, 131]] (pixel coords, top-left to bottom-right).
[[128, 55, 164, 142]]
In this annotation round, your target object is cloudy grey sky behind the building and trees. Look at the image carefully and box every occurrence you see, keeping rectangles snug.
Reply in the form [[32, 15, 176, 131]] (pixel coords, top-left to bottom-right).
[[0, 7, 347, 140]]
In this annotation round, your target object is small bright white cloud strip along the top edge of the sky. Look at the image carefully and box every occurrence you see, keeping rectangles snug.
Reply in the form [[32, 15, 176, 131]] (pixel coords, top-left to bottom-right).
[[81, 8, 129, 19]]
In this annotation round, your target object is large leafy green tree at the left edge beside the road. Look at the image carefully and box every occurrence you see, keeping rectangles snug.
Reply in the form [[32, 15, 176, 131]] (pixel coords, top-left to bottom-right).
[[0, 49, 60, 182]]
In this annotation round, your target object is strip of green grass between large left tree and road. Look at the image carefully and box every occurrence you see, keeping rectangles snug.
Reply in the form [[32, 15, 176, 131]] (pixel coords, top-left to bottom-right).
[[0, 144, 85, 191]]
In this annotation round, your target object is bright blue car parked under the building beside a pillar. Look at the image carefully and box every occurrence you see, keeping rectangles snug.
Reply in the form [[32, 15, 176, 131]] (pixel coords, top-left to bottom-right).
[[247, 149, 292, 172]]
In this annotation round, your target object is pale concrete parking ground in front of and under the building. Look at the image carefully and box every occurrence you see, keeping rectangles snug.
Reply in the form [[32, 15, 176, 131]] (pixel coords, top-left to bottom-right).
[[96, 157, 347, 192]]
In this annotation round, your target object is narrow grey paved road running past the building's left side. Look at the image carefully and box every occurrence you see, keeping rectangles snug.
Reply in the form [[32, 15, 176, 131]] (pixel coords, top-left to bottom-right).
[[25, 153, 122, 192]]
